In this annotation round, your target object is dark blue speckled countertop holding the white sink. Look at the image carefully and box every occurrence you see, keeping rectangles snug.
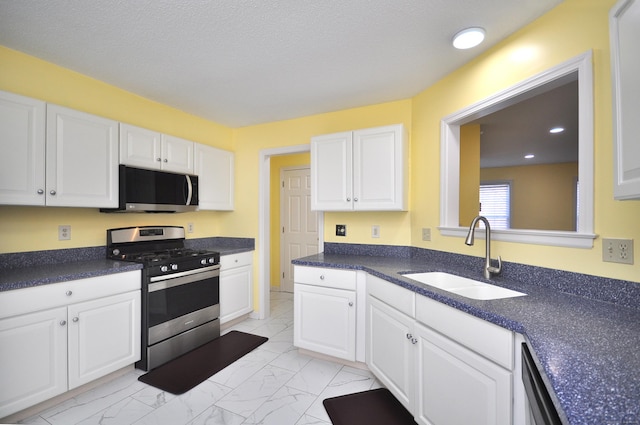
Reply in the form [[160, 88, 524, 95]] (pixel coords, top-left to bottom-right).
[[293, 244, 640, 425]]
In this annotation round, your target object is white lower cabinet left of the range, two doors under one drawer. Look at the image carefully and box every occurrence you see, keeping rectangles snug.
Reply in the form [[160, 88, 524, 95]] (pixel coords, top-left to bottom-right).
[[0, 271, 140, 418]]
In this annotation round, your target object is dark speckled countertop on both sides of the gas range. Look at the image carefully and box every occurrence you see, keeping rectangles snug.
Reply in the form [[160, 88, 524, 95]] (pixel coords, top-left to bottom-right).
[[0, 237, 254, 292]]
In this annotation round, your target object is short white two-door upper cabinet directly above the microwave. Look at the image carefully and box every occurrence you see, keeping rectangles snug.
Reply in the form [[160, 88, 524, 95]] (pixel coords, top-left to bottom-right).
[[120, 123, 195, 174]]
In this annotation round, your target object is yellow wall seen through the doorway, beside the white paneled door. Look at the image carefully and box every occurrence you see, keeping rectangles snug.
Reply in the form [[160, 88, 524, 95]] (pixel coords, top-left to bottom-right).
[[271, 153, 311, 287]]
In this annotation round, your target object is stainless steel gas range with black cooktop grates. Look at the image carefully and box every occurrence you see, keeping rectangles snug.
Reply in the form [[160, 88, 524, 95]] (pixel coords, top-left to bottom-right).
[[107, 226, 220, 370]]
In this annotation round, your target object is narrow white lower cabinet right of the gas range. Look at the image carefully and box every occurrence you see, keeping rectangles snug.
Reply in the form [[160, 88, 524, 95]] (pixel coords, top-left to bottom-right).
[[220, 251, 253, 324]]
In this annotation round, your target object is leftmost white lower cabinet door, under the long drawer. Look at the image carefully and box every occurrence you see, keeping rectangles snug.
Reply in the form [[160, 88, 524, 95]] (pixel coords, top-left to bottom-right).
[[0, 307, 67, 418]]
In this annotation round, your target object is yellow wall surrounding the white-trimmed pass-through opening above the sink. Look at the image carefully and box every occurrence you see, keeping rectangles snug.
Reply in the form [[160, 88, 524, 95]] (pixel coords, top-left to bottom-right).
[[411, 0, 640, 282]]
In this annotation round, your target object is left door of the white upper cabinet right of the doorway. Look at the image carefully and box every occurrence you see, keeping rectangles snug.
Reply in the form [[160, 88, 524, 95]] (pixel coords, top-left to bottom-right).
[[311, 131, 353, 211]]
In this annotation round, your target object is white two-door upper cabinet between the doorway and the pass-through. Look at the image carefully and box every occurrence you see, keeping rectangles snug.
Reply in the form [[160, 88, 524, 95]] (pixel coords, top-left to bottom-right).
[[311, 124, 408, 211]]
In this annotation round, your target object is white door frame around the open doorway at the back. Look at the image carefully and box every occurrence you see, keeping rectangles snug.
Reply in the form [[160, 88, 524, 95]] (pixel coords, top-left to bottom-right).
[[252, 144, 324, 319]]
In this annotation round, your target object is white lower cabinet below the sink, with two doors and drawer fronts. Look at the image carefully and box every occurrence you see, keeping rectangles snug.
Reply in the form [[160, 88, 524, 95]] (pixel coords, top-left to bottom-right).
[[366, 276, 515, 425]]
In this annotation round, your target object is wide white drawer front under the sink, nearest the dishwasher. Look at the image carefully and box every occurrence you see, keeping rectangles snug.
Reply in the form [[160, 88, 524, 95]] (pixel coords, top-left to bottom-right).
[[416, 295, 513, 370]]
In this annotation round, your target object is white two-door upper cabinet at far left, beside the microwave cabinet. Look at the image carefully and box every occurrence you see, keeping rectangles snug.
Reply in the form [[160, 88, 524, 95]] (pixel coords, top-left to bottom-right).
[[0, 92, 118, 208]]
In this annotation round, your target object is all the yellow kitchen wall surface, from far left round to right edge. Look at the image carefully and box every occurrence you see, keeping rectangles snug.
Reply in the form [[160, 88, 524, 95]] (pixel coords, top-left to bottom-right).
[[0, 0, 640, 290]]
